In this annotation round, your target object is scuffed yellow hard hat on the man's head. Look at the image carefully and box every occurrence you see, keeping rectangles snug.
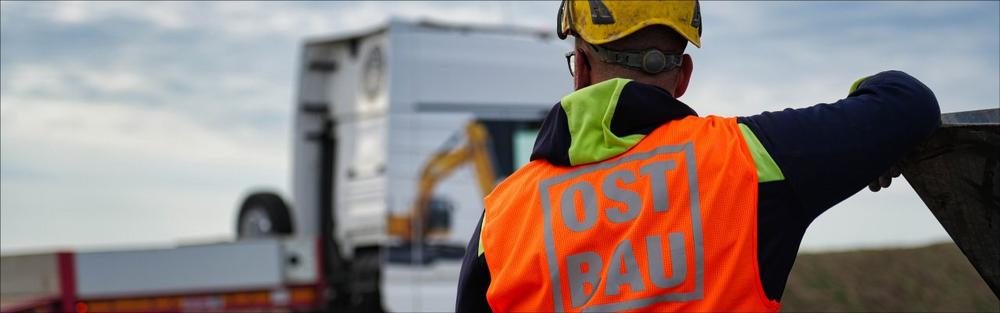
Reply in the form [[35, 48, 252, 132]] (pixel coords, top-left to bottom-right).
[[556, 0, 701, 48]]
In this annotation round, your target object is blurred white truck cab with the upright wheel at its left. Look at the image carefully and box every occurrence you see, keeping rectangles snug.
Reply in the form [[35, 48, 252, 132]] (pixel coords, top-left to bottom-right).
[[237, 20, 572, 311]]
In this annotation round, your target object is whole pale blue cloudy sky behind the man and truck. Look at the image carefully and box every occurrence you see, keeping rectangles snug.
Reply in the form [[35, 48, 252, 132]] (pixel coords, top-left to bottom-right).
[[0, 1, 1000, 254]]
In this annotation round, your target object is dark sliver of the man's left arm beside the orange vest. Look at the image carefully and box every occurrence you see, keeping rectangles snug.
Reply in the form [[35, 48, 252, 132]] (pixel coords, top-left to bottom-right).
[[455, 211, 493, 312]]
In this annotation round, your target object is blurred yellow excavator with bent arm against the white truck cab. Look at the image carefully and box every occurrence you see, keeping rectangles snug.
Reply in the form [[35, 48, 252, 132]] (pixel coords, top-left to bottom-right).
[[388, 121, 496, 243]]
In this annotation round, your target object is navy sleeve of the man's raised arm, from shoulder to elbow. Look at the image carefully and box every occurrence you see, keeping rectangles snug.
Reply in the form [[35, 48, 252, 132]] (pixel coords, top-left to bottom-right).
[[739, 71, 941, 221]]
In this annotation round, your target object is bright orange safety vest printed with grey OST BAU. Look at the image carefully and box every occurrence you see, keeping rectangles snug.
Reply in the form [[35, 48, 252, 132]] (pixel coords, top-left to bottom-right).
[[481, 116, 780, 312]]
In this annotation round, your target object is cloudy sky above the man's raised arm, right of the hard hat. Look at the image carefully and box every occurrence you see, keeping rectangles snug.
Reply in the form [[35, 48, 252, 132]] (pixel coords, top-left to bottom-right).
[[685, 2, 1000, 114]]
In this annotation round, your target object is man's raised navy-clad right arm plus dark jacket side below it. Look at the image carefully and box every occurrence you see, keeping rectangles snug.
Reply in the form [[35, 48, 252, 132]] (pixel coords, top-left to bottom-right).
[[738, 71, 940, 300]]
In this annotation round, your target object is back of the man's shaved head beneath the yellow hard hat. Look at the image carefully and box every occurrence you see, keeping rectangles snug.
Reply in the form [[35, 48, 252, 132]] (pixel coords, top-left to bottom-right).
[[576, 25, 691, 97]]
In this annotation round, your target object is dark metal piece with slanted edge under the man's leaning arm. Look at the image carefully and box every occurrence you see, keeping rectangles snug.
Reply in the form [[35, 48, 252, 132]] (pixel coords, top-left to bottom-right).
[[901, 109, 1000, 297]]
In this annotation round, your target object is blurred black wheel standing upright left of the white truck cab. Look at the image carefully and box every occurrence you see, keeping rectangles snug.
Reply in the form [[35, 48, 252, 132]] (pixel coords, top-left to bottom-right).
[[236, 192, 292, 238]]
